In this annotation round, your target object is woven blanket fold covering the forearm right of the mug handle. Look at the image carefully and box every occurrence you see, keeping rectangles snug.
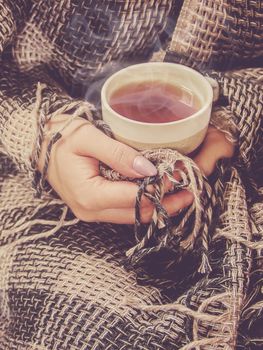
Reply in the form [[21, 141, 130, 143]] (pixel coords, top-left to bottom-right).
[[211, 68, 263, 169]]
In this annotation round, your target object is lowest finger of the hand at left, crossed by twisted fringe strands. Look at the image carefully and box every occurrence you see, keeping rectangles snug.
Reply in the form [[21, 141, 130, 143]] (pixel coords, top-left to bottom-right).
[[77, 190, 193, 224]]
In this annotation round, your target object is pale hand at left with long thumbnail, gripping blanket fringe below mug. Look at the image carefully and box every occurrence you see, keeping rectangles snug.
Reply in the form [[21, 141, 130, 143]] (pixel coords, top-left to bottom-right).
[[39, 119, 193, 224]]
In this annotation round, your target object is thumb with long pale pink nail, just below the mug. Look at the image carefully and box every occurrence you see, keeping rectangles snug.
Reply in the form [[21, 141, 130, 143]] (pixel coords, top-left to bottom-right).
[[75, 125, 157, 177]]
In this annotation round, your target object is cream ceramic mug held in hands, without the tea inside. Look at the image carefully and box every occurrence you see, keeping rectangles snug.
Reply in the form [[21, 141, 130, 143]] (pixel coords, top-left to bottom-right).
[[101, 62, 213, 154]]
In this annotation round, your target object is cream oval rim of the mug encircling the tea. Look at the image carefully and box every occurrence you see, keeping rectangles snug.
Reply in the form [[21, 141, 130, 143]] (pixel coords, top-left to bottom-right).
[[101, 62, 213, 127]]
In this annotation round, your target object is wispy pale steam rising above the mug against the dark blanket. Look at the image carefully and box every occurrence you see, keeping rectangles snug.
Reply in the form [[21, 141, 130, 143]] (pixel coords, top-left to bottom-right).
[[63, 2, 177, 102]]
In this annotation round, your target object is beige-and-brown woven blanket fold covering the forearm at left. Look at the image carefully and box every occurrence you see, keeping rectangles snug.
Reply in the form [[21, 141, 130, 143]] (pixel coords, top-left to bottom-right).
[[0, 59, 96, 194]]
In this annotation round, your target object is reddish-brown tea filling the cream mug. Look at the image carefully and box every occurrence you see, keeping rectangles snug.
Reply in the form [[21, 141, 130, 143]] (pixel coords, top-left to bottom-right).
[[109, 81, 200, 123]]
